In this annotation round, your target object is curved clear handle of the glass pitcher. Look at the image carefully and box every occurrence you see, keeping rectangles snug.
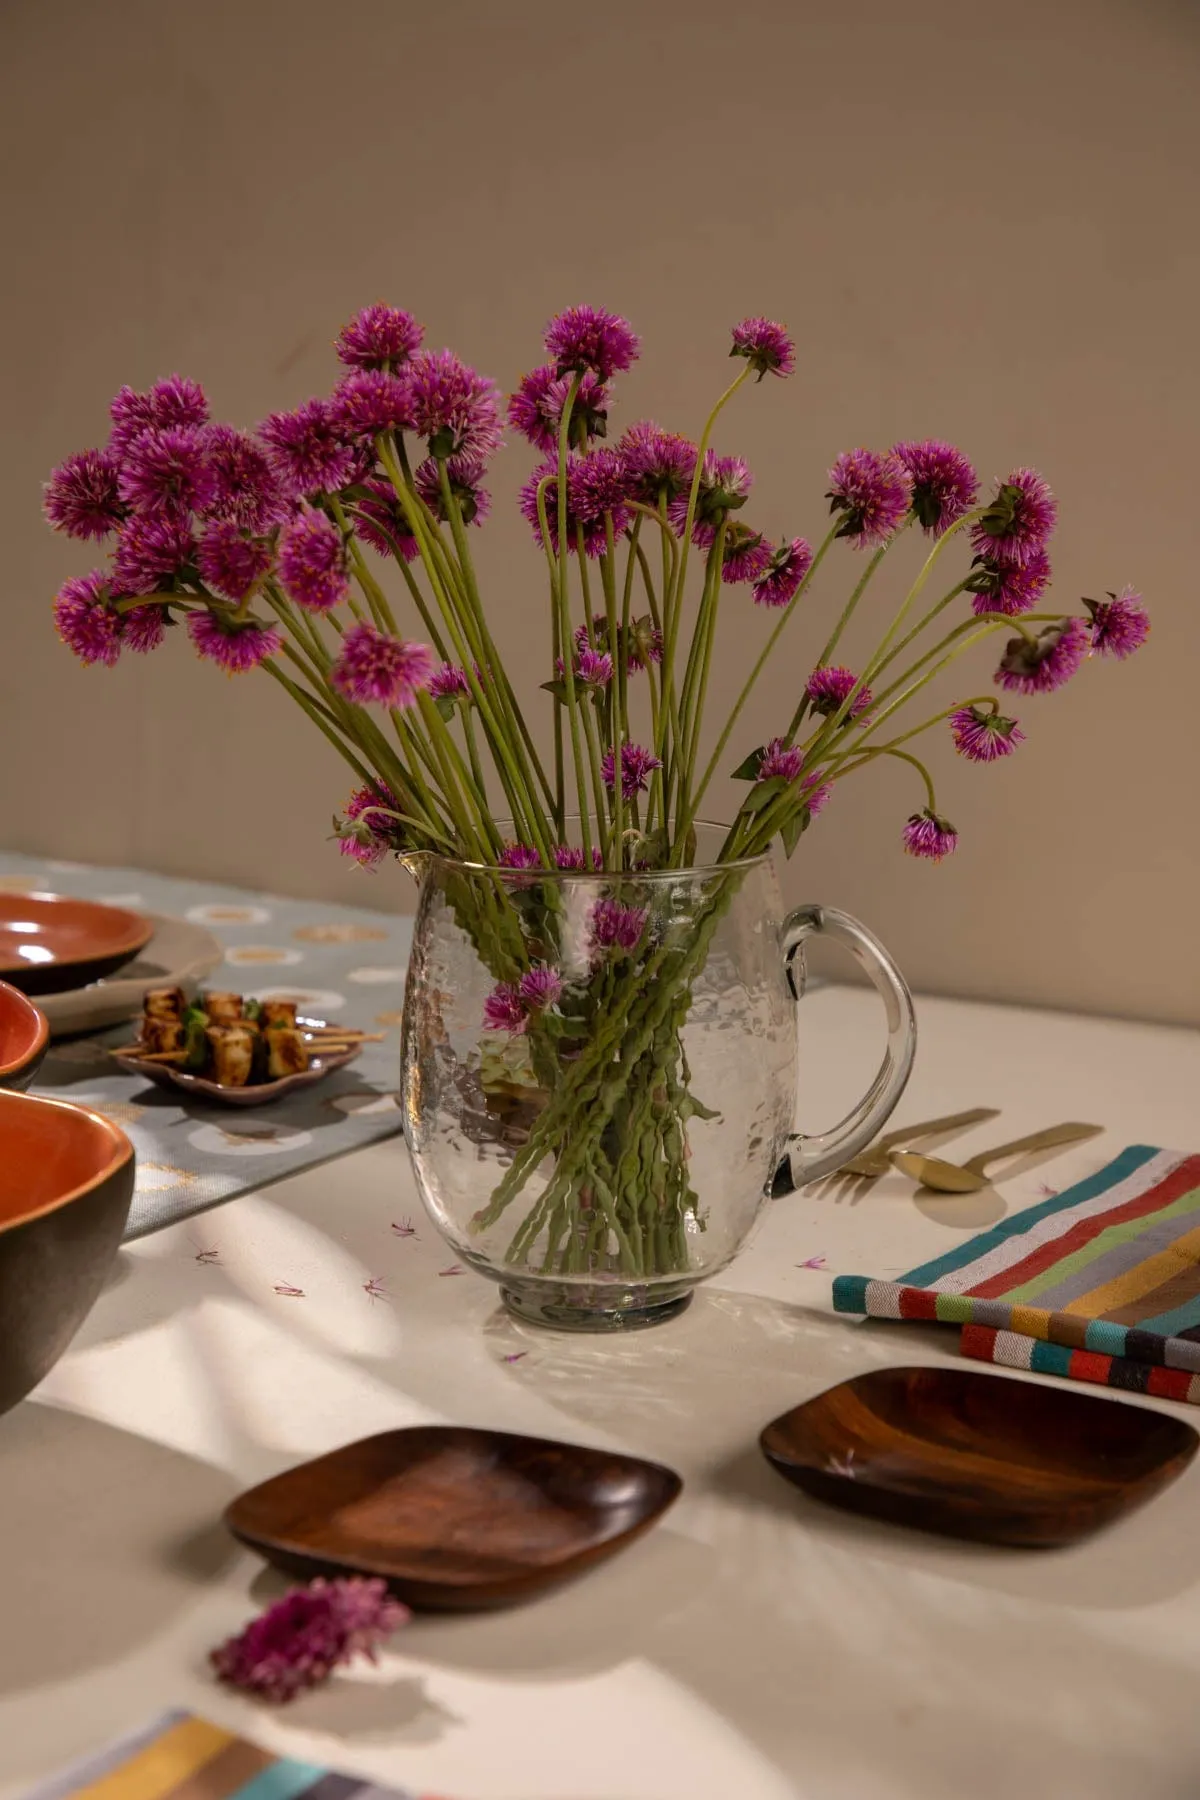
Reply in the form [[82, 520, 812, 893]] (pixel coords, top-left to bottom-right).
[[772, 905, 918, 1195]]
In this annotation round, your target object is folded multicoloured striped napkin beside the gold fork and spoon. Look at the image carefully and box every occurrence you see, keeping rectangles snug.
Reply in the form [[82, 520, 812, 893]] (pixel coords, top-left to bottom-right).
[[833, 1145, 1200, 1406]]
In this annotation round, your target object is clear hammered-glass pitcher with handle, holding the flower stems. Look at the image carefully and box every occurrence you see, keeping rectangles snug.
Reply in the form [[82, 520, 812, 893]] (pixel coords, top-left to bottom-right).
[[401, 828, 916, 1330]]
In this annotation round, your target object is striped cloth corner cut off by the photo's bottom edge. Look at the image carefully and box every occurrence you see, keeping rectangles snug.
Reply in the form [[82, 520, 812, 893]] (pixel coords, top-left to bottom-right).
[[25, 1712, 446, 1800]]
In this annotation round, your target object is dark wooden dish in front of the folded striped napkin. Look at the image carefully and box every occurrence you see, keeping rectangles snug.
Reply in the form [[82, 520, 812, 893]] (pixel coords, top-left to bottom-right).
[[759, 1368, 1200, 1546]]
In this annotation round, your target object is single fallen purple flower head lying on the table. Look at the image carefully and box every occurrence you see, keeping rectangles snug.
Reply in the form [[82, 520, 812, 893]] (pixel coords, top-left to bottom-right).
[[209, 1575, 410, 1703]]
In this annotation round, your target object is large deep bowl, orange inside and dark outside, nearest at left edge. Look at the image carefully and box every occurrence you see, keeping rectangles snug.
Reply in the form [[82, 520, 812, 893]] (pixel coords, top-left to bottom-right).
[[0, 1091, 133, 1413]]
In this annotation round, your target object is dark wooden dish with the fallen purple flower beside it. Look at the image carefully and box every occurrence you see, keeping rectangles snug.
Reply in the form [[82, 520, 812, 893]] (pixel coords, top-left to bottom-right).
[[225, 1426, 684, 1613]]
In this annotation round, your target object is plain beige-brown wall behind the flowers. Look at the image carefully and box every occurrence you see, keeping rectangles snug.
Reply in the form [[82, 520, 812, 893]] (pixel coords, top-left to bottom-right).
[[0, 0, 1200, 1022]]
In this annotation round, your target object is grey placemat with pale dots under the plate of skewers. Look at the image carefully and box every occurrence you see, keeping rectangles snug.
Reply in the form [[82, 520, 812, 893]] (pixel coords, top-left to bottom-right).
[[0, 851, 412, 1238]]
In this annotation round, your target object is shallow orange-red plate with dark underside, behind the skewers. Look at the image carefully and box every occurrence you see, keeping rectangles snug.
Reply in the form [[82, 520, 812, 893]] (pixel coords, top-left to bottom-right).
[[0, 893, 153, 994]]
